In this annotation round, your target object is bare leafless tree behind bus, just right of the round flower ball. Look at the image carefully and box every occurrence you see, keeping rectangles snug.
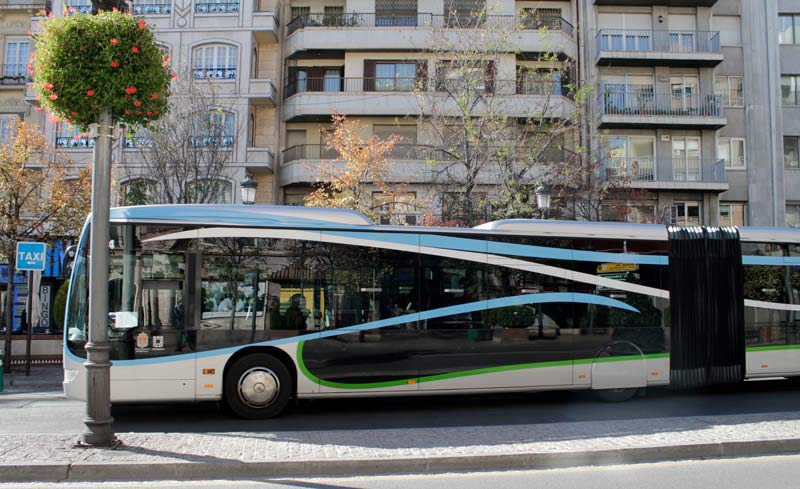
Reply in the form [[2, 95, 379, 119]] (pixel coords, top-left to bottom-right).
[[120, 77, 240, 205]]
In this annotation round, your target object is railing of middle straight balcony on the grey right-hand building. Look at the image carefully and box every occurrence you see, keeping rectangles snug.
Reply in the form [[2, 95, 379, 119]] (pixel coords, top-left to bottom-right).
[[597, 86, 723, 117]]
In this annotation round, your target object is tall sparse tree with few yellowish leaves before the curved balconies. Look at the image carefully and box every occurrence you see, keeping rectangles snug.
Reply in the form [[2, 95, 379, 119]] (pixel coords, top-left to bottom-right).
[[415, 3, 640, 225]]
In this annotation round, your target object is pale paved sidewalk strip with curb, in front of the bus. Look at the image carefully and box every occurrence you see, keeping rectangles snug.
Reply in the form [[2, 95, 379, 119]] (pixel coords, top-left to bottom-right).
[[0, 398, 800, 481]]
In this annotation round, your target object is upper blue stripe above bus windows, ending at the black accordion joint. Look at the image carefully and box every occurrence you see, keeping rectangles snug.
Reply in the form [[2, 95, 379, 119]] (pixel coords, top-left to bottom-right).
[[322, 231, 669, 265]]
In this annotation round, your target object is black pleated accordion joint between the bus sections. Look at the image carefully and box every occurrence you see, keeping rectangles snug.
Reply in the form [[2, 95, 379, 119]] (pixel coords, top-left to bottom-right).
[[669, 227, 745, 388]]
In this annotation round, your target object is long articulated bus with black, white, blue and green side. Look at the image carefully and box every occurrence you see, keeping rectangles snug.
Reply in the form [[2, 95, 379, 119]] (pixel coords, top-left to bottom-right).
[[64, 205, 800, 418]]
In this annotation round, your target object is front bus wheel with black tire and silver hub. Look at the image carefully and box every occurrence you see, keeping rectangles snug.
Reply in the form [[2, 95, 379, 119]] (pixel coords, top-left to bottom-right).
[[224, 353, 293, 419]]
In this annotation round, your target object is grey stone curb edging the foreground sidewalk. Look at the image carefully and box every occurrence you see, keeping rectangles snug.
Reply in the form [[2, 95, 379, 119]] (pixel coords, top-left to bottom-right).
[[0, 438, 800, 482]]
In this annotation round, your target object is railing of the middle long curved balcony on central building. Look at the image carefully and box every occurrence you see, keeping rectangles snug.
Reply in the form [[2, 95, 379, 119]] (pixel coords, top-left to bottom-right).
[[284, 77, 570, 97]]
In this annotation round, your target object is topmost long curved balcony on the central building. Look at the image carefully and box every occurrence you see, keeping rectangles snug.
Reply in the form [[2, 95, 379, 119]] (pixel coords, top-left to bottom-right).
[[285, 13, 577, 58]]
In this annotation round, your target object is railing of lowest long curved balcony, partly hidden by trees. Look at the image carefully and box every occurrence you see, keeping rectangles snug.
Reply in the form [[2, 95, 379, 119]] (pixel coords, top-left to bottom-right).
[[283, 143, 570, 163]]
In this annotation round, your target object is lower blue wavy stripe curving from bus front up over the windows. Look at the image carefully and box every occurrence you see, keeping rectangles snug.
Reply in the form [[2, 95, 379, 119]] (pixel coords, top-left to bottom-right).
[[94, 292, 639, 366]]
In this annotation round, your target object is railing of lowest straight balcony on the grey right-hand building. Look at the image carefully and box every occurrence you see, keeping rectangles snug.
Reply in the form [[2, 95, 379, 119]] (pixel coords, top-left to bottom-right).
[[601, 156, 725, 183]]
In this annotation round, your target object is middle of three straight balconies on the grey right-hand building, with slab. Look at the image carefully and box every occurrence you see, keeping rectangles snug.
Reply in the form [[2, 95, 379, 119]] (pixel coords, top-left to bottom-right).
[[597, 86, 727, 129]]
